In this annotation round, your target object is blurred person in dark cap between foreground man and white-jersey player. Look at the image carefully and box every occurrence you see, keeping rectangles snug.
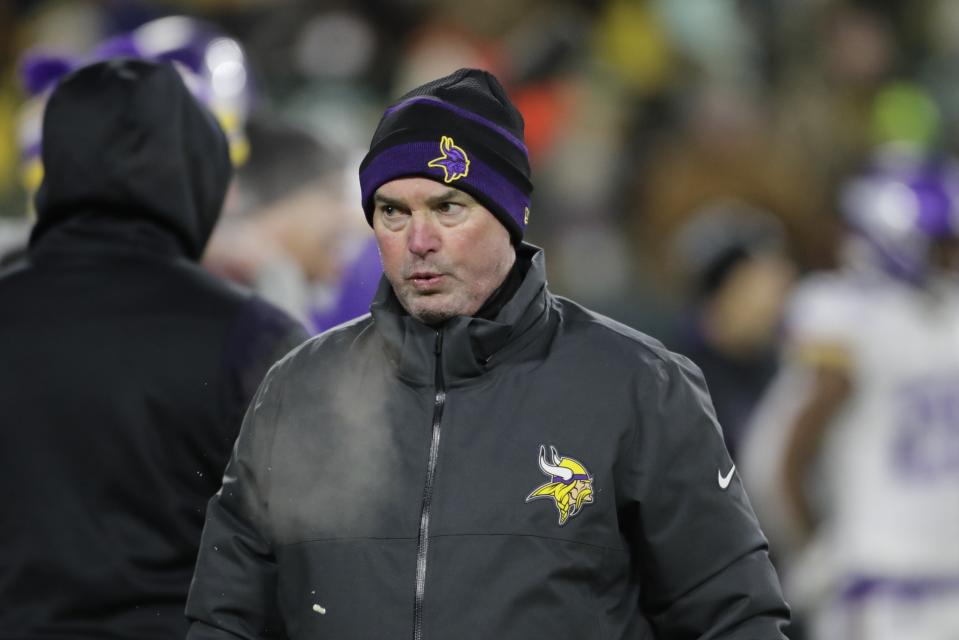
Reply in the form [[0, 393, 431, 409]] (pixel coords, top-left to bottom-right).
[[675, 200, 796, 460]]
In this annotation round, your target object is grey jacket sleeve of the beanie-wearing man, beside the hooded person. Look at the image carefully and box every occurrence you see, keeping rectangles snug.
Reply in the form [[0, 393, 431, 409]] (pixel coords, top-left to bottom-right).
[[186, 367, 286, 640]]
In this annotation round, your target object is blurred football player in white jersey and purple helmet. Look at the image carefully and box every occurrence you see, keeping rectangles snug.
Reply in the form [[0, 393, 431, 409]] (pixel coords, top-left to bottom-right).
[[741, 152, 959, 640]]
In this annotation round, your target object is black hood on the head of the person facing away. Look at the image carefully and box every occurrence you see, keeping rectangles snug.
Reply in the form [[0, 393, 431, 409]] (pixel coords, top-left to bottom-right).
[[30, 59, 232, 259]]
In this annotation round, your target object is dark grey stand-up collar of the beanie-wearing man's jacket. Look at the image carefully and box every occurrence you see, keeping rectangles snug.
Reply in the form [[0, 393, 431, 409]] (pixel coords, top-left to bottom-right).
[[370, 243, 551, 386]]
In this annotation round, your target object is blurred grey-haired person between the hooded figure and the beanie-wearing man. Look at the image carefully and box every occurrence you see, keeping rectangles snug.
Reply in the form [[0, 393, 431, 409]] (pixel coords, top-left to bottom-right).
[[203, 114, 382, 333]]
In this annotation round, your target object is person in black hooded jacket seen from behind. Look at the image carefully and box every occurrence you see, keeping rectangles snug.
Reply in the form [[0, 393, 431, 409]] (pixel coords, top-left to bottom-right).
[[0, 59, 306, 640]]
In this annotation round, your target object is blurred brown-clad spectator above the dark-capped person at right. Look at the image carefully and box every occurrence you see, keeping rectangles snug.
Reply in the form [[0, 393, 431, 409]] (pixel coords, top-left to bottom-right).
[[631, 79, 833, 296]]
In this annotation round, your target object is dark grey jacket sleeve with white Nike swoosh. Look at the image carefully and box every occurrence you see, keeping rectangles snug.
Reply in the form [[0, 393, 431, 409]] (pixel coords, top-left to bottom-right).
[[627, 354, 789, 640]]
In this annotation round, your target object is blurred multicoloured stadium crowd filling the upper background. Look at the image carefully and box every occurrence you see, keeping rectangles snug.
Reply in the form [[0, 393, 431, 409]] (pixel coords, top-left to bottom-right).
[[0, 0, 959, 324]]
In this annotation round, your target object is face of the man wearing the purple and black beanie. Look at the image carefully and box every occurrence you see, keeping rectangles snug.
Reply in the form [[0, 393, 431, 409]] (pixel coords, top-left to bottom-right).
[[373, 178, 516, 324]]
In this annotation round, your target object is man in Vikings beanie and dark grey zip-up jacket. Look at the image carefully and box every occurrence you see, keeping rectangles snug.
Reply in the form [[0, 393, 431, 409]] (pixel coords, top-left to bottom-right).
[[187, 69, 788, 640]]
